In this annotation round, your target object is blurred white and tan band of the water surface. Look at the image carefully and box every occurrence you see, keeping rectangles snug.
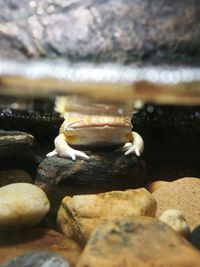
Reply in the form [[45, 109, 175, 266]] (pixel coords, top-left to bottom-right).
[[0, 60, 200, 104]]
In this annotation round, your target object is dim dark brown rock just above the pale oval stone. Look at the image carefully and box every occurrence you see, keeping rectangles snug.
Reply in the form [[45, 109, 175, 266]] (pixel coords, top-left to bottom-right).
[[0, 170, 33, 187]]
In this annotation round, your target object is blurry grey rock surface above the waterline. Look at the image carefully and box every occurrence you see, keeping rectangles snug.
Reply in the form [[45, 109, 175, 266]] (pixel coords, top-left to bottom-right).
[[0, 0, 200, 62]]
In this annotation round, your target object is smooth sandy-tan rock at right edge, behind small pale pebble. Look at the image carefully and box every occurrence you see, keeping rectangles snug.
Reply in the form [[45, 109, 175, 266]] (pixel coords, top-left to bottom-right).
[[153, 177, 200, 230]]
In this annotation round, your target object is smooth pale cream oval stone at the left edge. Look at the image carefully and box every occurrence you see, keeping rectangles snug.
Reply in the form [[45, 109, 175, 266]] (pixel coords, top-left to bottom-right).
[[0, 183, 50, 228]]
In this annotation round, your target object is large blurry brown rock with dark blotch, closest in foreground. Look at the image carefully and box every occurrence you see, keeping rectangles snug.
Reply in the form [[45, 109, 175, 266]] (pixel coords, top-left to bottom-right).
[[77, 216, 200, 267]]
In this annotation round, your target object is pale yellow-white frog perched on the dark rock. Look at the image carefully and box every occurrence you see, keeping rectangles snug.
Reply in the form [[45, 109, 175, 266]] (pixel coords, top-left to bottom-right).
[[47, 97, 144, 160]]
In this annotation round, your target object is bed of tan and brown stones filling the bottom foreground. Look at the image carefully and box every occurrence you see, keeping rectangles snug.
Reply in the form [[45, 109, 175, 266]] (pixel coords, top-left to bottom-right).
[[0, 177, 200, 267]]
